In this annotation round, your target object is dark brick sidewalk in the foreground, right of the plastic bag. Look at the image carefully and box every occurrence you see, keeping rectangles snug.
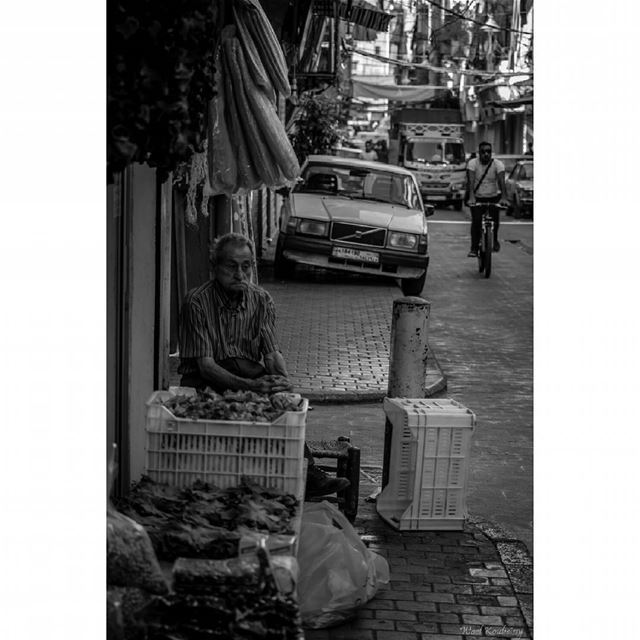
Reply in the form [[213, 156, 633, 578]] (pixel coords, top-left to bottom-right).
[[305, 470, 533, 640]]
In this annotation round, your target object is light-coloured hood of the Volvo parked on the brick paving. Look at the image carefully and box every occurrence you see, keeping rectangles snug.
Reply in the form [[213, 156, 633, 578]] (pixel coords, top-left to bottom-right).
[[293, 193, 425, 233]]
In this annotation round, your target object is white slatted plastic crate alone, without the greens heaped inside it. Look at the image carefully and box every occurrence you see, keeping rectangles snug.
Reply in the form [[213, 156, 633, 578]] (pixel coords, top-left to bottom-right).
[[145, 387, 309, 504]]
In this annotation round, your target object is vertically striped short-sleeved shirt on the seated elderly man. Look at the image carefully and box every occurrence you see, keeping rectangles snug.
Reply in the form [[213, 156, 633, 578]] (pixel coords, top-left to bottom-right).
[[178, 280, 280, 375]]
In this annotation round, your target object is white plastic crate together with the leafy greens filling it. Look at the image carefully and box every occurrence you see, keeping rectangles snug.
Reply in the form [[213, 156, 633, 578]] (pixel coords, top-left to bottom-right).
[[145, 387, 309, 501]]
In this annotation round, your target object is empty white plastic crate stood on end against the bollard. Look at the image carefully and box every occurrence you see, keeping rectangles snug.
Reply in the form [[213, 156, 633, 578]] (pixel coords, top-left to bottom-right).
[[376, 398, 475, 531]]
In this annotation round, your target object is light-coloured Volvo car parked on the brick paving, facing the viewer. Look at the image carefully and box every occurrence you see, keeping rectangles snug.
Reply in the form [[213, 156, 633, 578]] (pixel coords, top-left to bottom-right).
[[274, 155, 434, 295]]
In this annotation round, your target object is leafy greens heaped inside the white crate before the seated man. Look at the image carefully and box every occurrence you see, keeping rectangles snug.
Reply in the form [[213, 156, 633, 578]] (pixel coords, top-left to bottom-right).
[[162, 389, 302, 422]]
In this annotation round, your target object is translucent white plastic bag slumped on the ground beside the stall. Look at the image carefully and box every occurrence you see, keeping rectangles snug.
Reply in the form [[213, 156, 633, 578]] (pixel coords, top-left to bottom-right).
[[298, 502, 389, 629]]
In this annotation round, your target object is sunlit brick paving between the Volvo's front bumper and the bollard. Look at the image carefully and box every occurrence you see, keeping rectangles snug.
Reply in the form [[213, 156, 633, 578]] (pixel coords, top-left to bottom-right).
[[260, 267, 446, 402]]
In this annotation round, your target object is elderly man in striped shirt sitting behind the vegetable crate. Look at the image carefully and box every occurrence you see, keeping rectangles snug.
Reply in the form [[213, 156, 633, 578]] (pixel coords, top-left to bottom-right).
[[178, 233, 349, 497]]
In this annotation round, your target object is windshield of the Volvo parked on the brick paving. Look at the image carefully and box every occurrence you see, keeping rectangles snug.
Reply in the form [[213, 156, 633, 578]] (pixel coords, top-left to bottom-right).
[[294, 162, 421, 210]]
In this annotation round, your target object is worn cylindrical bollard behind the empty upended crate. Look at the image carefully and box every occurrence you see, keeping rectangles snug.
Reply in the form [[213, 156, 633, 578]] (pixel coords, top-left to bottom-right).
[[382, 296, 431, 489]]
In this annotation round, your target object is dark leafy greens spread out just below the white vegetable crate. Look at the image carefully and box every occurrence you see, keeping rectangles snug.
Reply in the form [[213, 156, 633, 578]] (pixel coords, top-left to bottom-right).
[[118, 476, 298, 560]]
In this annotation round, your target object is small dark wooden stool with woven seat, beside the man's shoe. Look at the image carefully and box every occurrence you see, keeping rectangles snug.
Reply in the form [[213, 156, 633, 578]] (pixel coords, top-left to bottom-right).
[[307, 436, 360, 522]]
